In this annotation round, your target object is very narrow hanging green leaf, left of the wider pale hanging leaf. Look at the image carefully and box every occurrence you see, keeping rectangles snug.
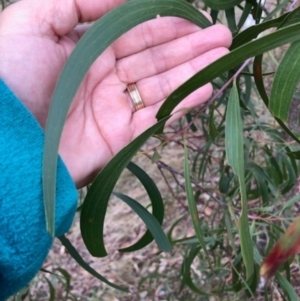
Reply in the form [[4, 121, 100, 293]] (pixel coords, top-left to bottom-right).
[[184, 140, 210, 262]]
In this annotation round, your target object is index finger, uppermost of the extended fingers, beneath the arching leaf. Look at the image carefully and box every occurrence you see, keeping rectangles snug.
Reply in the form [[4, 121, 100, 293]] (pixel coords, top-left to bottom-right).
[[112, 11, 210, 59]]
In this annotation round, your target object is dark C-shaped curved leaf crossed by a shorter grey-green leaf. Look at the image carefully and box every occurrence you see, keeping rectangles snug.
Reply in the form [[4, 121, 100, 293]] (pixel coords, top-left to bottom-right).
[[119, 162, 164, 252]]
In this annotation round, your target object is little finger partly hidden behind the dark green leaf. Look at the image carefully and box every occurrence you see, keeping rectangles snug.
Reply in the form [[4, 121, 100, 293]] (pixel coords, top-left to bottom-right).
[[132, 83, 213, 138]]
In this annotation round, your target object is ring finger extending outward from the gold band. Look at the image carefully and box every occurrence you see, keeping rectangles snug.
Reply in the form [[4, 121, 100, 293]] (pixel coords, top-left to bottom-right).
[[128, 47, 229, 106]]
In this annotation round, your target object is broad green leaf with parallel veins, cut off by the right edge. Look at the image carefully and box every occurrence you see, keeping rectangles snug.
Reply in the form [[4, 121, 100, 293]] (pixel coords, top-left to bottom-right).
[[269, 41, 300, 121]]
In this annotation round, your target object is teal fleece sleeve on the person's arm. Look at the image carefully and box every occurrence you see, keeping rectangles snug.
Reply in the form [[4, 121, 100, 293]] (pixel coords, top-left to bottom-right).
[[0, 80, 77, 301]]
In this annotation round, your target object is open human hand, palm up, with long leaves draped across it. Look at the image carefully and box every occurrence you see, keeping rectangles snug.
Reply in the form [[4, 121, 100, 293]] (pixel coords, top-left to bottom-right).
[[0, 0, 232, 187]]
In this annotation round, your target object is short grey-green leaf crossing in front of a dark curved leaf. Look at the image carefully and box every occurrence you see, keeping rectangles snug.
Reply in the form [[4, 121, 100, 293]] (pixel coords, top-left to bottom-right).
[[113, 192, 172, 253]]
